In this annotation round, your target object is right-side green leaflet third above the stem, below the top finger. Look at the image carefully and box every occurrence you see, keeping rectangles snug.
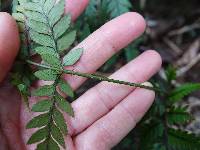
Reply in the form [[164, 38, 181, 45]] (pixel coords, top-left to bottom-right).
[[53, 15, 71, 39]]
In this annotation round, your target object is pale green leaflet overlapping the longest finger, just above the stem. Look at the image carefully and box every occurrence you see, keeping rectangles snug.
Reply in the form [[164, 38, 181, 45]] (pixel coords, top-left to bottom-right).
[[63, 48, 83, 66]]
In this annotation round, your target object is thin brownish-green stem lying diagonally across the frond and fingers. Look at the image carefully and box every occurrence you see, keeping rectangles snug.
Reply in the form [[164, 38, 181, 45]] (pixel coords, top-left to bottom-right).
[[26, 60, 165, 93]]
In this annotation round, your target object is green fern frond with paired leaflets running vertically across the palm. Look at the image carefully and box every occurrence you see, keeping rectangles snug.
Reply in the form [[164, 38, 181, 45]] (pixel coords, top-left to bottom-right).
[[14, 0, 83, 150]]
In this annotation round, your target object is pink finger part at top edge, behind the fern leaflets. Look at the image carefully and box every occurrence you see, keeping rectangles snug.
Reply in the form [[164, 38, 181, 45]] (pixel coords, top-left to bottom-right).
[[65, 0, 89, 20]]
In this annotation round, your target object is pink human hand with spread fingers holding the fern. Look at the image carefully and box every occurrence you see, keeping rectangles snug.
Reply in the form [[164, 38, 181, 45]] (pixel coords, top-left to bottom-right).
[[0, 0, 161, 150]]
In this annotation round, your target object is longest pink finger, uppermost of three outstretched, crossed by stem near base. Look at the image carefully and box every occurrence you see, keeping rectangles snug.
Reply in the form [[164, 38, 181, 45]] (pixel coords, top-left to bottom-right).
[[65, 12, 145, 89]]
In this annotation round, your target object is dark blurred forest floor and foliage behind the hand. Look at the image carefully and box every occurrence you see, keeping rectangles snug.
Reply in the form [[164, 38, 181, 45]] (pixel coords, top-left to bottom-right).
[[0, 0, 200, 150]]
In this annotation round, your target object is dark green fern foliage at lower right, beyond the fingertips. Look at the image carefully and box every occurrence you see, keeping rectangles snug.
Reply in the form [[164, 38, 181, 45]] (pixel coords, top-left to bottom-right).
[[115, 67, 200, 150]]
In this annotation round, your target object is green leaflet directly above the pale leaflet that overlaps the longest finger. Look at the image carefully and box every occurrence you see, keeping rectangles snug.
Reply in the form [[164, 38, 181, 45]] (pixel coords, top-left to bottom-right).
[[57, 31, 76, 52]]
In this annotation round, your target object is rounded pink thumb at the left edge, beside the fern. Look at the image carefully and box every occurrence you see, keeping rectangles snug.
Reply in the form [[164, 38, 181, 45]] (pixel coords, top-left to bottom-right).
[[0, 12, 20, 82]]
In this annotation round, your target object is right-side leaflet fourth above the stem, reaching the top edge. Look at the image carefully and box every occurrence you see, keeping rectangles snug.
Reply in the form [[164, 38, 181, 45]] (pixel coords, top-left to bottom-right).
[[49, 0, 65, 26]]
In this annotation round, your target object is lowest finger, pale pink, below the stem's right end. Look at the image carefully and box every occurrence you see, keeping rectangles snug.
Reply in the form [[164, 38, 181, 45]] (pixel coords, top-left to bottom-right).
[[75, 86, 155, 150]]
